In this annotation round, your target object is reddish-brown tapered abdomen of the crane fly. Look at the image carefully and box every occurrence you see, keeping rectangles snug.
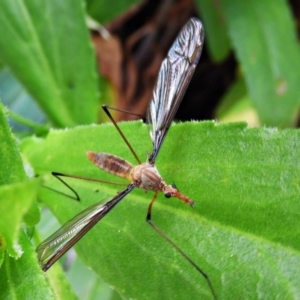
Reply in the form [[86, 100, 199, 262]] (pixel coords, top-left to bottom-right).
[[86, 151, 133, 180]]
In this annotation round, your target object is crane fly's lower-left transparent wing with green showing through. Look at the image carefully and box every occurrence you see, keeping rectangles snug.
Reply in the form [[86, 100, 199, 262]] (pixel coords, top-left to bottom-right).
[[36, 184, 135, 271]]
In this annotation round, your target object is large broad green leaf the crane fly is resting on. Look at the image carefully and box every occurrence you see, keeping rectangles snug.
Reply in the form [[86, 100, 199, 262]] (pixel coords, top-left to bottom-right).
[[22, 122, 300, 299]]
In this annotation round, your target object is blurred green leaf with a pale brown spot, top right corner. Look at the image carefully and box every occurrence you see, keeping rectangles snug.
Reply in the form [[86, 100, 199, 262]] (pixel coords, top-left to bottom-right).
[[221, 0, 300, 126]]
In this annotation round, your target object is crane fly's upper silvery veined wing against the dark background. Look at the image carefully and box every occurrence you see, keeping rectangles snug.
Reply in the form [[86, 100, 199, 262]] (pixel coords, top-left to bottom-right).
[[147, 18, 204, 163]]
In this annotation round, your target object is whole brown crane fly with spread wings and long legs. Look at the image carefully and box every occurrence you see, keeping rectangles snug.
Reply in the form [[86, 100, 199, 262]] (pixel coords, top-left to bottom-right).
[[36, 18, 216, 298]]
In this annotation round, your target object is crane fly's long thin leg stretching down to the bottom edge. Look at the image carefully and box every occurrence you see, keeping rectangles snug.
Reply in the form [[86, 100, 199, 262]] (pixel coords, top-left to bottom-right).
[[146, 192, 218, 300]]
